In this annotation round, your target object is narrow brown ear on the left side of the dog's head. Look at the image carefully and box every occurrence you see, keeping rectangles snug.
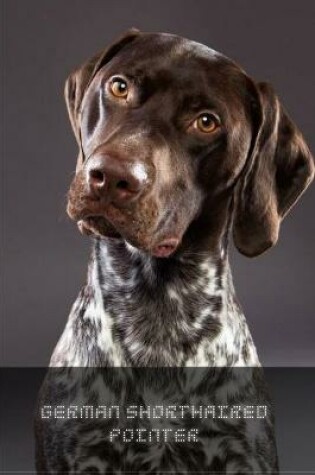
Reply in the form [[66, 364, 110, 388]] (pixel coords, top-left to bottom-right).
[[64, 28, 141, 146]]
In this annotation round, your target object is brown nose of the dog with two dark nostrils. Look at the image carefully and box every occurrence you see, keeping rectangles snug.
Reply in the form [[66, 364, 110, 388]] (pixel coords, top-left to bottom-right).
[[87, 155, 148, 205]]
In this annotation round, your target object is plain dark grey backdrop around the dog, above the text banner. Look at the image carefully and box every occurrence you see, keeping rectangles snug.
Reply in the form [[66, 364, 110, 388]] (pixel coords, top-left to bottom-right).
[[1, 0, 315, 366]]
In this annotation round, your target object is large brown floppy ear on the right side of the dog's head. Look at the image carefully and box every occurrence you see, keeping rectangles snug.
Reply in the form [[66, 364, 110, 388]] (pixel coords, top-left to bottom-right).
[[233, 82, 314, 257]]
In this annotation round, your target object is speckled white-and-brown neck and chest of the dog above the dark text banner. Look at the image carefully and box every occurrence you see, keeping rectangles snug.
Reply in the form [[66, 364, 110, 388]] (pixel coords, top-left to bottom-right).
[[52, 239, 259, 366]]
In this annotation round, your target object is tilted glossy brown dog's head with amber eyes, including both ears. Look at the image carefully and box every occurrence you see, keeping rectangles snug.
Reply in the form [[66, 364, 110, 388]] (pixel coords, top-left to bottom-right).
[[65, 30, 314, 257]]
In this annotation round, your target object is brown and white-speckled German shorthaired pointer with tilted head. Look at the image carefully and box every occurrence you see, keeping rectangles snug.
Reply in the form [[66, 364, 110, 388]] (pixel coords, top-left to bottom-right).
[[38, 30, 314, 474]]
